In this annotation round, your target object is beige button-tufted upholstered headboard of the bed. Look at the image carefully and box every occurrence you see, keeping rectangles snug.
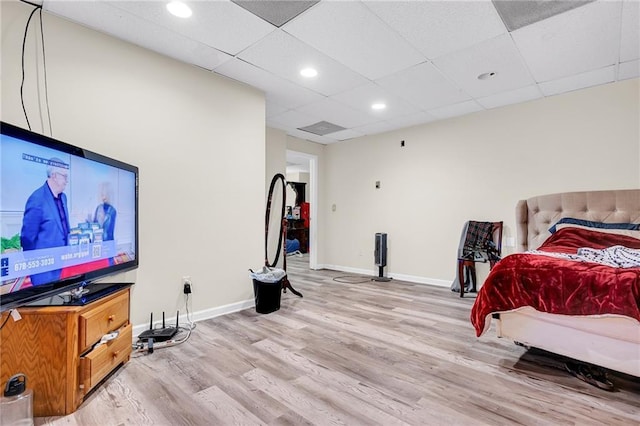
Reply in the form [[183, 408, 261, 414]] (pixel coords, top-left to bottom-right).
[[516, 189, 640, 252]]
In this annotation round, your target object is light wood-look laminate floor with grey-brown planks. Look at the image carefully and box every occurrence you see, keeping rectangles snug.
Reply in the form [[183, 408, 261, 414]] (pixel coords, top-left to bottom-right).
[[36, 257, 640, 426]]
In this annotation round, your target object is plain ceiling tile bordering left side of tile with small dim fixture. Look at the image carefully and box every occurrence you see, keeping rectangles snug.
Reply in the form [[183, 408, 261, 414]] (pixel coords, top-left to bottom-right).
[[376, 62, 470, 110]]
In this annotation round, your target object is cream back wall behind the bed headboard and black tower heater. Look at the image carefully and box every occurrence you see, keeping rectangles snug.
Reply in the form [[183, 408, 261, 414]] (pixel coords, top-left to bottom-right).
[[319, 79, 640, 285]]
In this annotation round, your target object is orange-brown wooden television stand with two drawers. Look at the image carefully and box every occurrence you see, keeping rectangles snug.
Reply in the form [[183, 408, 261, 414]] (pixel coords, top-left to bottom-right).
[[0, 284, 132, 417]]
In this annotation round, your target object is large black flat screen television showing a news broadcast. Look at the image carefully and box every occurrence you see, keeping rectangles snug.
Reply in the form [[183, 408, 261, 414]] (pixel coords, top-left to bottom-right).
[[0, 122, 138, 311]]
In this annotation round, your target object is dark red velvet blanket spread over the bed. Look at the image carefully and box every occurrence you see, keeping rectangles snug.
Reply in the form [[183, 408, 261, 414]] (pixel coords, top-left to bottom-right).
[[471, 228, 640, 336]]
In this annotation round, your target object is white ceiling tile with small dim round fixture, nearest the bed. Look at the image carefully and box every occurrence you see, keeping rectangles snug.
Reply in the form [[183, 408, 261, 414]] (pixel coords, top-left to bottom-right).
[[433, 34, 535, 97]]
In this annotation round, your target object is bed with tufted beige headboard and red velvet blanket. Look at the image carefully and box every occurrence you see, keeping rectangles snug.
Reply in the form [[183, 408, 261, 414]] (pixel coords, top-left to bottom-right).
[[471, 189, 640, 377]]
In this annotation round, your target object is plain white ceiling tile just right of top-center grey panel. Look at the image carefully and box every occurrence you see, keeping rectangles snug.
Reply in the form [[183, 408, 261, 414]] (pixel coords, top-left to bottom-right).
[[282, 1, 425, 80]]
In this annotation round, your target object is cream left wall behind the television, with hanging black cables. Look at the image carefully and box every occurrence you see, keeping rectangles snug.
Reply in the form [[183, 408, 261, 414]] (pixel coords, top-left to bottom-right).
[[1, 1, 265, 324]]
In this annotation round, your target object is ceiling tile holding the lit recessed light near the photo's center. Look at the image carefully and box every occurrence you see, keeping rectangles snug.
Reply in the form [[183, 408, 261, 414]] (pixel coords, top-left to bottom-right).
[[238, 30, 369, 96]]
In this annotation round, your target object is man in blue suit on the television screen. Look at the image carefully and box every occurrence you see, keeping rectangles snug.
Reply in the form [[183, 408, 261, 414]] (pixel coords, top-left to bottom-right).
[[20, 158, 69, 285]]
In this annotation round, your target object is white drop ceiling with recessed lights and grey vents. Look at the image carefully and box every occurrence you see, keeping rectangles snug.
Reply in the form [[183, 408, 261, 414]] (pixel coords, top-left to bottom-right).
[[44, 0, 640, 144]]
